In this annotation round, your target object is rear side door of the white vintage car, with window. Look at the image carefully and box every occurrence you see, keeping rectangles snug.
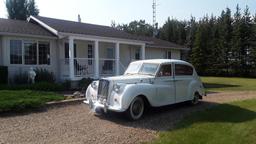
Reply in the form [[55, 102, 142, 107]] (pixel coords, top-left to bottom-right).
[[174, 64, 193, 102]]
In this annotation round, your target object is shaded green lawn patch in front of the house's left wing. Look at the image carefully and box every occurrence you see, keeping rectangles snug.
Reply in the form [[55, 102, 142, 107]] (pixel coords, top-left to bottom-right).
[[0, 90, 64, 112]]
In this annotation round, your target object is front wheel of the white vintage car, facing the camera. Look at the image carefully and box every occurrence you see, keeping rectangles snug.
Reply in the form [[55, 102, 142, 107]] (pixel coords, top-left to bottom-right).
[[126, 97, 145, 120]]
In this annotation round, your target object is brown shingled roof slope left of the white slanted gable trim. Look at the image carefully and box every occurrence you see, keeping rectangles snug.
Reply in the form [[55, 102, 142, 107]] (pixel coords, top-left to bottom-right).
[[0, 18, 54, 37]]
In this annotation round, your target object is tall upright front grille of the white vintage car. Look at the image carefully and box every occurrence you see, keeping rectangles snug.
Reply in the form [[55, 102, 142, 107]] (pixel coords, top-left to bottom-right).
[[97, 79, 109, 103]]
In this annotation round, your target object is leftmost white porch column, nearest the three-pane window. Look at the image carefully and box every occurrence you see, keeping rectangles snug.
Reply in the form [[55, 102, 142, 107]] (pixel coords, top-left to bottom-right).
[[68, 37, 75, 80]]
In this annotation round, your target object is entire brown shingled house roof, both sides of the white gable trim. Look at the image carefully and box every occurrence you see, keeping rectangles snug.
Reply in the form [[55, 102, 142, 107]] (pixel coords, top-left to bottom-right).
[[0, 16, 187, 49]]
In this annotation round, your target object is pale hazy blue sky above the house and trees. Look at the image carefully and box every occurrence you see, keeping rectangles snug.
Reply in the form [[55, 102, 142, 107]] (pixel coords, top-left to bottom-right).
[[0, 0, 256, 25]]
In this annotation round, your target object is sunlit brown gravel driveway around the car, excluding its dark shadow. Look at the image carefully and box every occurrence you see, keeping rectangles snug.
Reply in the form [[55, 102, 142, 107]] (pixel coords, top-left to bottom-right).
[[0, 92, 256, 144]]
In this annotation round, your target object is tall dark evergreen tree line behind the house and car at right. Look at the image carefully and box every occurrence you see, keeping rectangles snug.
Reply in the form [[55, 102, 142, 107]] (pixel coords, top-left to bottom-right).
[[112, 5, 256, 77]]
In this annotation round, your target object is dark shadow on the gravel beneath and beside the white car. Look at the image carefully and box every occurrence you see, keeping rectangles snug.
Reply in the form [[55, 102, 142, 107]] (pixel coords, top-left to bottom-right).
[[97, 101, 216, 131]]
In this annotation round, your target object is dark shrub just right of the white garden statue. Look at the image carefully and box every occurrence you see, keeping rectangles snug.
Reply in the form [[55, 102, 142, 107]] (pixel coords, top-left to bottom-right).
[[35, 68, 55, 83]]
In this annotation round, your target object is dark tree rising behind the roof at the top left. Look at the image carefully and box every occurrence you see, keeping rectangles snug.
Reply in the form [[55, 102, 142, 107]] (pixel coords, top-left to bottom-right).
[[6, 0, 39, 20]]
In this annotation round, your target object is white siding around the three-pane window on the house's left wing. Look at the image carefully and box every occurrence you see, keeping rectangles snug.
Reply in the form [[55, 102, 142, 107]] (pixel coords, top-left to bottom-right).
[[2, 36, 59, 79]]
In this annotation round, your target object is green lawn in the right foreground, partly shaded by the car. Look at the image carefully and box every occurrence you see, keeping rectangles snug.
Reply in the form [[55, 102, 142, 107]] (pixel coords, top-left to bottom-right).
[[152, 99, 256, 144]]
